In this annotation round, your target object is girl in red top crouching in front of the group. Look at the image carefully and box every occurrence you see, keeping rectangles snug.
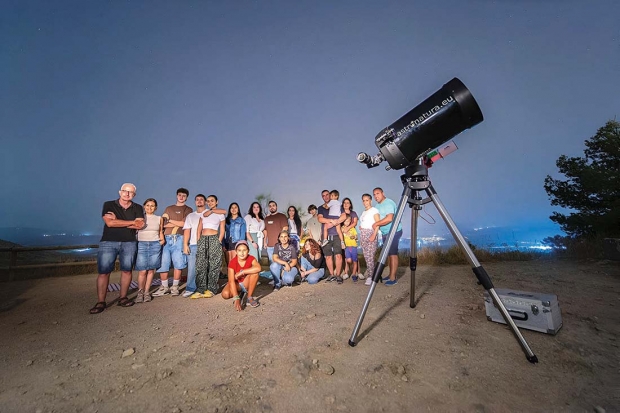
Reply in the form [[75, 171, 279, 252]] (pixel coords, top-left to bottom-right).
[[222, 241, 261, 311]]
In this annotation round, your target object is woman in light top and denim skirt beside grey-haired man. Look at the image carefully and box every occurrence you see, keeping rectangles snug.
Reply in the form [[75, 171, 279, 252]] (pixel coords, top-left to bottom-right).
[[135, 198, 165, 303]]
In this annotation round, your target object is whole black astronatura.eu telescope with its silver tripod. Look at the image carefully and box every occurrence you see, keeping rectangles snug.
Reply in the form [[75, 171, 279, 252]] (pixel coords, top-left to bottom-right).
[[349, 78, 538, 363]]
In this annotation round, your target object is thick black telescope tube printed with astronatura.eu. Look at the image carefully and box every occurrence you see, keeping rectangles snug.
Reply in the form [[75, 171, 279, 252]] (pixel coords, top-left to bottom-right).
[[375, 78, 483, 169]]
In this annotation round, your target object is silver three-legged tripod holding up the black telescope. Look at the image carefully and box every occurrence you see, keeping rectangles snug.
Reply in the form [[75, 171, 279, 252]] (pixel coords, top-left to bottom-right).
[[349, 160, 538, 363]]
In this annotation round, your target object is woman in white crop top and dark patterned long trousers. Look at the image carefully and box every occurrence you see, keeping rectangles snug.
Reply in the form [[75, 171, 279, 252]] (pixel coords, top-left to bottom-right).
[[195, 195, 226, 298]]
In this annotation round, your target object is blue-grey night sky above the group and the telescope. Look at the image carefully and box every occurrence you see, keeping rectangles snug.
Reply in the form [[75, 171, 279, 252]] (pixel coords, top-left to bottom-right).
[[0, 0, 620, 238]]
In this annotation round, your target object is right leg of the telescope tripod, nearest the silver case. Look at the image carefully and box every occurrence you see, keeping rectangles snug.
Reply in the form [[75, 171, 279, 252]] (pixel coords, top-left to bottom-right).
[[426, 185, 538, 363]]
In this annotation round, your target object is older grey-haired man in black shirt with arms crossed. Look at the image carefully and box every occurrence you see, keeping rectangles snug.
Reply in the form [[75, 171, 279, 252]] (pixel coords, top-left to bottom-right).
[[90, 183, 144, 314]]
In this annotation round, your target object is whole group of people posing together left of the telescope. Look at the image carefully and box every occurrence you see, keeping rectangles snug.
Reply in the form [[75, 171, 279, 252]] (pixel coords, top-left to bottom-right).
[[90, 183, 402, 314]]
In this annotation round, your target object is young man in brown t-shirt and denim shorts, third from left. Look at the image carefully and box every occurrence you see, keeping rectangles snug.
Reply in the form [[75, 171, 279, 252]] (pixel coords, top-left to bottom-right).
[[153, 188, 193, 297]]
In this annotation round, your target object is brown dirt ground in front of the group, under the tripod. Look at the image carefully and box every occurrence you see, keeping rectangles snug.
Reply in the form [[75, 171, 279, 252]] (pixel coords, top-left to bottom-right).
[[0, 260, 620, 413]]
